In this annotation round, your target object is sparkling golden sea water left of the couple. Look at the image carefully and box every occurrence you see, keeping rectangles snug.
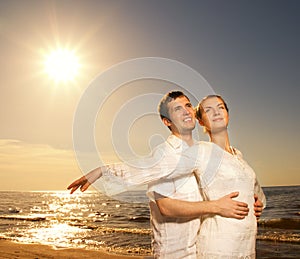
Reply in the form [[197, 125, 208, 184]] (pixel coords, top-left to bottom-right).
[[0, 191, 150, 257]]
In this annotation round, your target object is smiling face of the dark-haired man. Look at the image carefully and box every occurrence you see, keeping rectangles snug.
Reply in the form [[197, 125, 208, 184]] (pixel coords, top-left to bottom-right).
[[164, 96, 196, 136]]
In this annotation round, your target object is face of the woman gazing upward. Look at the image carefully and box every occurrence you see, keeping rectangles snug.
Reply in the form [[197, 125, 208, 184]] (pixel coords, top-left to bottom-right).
[[199, 97, 229, 133]]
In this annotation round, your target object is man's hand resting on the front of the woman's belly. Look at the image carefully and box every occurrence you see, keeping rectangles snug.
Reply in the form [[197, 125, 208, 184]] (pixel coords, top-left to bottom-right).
[[215, 192, 249, 219]]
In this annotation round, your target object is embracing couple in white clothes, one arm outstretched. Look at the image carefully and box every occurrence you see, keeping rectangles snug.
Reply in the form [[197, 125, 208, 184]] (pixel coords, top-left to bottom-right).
[[68, 91, 266, 259]]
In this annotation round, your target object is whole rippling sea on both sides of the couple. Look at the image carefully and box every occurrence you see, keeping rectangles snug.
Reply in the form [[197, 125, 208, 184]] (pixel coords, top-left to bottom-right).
[[0, 186, 300, 259]]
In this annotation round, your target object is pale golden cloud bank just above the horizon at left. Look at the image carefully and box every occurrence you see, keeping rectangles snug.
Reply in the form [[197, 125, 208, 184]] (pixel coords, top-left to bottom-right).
[[0, 139, 81, 190]]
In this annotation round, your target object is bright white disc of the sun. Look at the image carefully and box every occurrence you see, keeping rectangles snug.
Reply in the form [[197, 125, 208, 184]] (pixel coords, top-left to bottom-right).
[[45, 49, 80, 82]]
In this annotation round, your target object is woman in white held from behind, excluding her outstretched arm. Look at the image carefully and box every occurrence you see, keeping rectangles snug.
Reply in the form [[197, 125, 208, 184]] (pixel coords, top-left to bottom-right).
[[186, 95, 266, 259]]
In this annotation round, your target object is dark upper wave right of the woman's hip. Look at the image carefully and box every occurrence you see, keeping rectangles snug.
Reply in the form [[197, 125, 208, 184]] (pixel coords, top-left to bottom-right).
[[258, 218, 300, 229]]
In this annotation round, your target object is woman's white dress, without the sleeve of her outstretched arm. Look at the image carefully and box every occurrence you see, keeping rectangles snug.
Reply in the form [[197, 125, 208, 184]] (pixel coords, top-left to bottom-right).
[[190, 142, 265, 259]]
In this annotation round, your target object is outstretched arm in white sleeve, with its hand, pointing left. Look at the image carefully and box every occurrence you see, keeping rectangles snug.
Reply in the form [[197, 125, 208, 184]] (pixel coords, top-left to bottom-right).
[[67, 147, 198, 194]]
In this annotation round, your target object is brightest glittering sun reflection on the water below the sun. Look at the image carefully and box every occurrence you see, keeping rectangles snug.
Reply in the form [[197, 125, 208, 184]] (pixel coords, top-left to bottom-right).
[[3, 192, 103, 248]]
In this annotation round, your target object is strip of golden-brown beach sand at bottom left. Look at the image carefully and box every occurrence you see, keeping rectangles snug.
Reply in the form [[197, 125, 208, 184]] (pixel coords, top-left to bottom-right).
[[0, 239, 144, 259]]
